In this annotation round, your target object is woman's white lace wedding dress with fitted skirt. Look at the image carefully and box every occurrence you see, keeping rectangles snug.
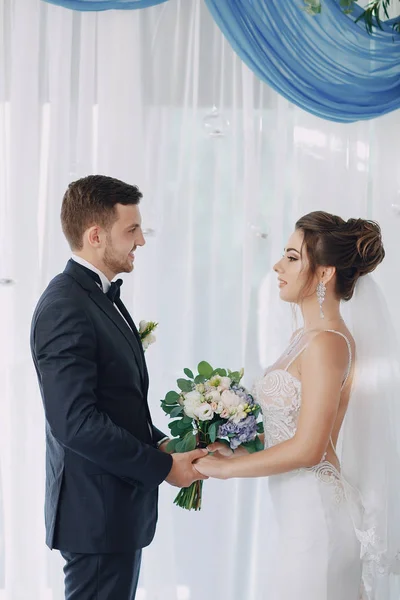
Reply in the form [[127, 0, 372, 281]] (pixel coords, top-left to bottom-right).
[[254, 332, 362, 600]]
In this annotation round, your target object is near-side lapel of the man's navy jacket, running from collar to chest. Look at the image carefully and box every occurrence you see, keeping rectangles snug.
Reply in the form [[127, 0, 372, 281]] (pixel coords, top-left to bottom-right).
[[64, 259, 148, 389]]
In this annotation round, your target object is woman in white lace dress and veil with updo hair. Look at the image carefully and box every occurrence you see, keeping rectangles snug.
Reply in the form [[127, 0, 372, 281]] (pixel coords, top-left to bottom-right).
[[196, 212, 400, 600]]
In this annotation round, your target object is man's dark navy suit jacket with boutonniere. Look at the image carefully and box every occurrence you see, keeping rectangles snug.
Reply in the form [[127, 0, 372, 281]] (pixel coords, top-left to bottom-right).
[[31, 260, 172, 553]]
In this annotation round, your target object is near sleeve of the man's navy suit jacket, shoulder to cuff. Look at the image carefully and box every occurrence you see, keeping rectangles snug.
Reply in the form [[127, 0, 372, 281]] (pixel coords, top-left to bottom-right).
[[33, 299, 172, 490]]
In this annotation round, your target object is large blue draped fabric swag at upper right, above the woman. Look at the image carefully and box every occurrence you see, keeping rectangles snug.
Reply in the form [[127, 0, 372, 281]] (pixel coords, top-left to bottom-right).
[[205, 0, 400, 123]]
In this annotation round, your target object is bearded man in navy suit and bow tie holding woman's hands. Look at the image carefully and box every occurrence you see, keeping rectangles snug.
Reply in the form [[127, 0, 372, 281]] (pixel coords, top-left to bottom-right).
[[31, 175, 204, 600]]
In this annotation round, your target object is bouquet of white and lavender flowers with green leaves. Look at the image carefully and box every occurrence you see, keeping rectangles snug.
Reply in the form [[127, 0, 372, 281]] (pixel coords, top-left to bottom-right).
[[161, 361, 263, 510]]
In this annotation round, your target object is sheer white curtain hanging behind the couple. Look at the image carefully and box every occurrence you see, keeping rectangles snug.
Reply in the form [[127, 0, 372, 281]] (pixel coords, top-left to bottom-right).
[[0, 0, 400, 600]]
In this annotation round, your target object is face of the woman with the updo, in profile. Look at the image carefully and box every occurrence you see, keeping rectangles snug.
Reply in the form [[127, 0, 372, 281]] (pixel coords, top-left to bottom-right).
[[274, 229, 317, 303]]
